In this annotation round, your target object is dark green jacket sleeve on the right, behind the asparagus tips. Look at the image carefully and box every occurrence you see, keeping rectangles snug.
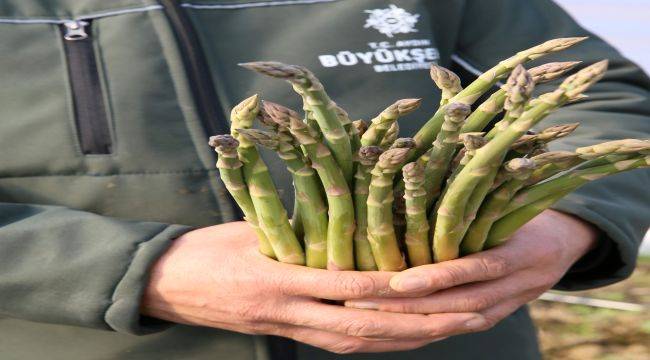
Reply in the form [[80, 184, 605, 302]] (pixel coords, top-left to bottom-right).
[[456, 0, 650, 290]]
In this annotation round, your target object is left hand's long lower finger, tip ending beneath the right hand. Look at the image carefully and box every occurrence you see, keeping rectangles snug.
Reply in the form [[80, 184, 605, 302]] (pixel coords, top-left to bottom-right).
[[276, 299, 485, 339]]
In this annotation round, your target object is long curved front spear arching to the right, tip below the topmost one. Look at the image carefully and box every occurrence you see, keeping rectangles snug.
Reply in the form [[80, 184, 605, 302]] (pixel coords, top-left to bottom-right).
[[434, 61, 607, 261]]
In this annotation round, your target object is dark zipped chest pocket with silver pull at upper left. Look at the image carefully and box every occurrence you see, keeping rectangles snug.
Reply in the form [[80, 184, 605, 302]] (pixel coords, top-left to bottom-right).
[[61, 20, 113, 155]]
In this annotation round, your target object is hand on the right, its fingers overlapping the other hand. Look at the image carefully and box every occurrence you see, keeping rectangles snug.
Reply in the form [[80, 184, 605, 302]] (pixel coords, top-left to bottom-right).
[[345, 210, 598, 330]]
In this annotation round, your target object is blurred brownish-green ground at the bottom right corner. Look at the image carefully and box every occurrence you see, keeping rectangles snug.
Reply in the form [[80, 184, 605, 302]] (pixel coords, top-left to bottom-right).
[[531, 257, 650, 360]]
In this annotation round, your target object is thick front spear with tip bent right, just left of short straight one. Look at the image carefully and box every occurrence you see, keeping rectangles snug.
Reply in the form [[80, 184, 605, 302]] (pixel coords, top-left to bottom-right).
[[367, 148, 410, 271]]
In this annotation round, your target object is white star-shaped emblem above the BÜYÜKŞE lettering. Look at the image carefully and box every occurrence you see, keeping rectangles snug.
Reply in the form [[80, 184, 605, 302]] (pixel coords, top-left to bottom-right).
[[364, 4, 420, 38]]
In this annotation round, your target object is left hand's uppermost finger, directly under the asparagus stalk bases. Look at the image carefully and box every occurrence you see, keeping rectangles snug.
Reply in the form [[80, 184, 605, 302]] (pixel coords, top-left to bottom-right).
[[275, 263, 395, 300]]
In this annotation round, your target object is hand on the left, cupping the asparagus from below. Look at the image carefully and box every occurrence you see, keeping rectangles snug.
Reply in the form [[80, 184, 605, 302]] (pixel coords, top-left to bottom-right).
[[141, 222, 485, 353]]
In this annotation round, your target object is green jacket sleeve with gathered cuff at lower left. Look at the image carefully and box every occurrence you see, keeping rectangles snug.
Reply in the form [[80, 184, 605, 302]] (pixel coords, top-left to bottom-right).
[[0, 203, 188, 334]]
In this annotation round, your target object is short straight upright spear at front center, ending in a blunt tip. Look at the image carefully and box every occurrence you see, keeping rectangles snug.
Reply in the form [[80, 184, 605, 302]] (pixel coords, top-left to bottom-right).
[[402, 162, 431, 266]]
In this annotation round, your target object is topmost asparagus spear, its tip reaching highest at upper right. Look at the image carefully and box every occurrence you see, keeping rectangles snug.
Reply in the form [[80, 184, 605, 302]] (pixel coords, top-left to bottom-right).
[[411, 37, 586, 159]]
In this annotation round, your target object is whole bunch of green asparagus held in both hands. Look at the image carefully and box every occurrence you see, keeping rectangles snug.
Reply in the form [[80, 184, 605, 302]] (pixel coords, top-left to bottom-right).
[[210, 38, 650, 271]]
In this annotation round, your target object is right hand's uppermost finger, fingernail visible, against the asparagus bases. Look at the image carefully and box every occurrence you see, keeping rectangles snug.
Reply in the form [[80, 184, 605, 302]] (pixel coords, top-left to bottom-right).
[[390, 246, 528, 296]]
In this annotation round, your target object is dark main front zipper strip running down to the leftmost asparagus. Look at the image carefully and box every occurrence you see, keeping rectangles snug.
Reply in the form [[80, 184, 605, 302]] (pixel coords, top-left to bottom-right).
[[160, 0, 229, 136]]
